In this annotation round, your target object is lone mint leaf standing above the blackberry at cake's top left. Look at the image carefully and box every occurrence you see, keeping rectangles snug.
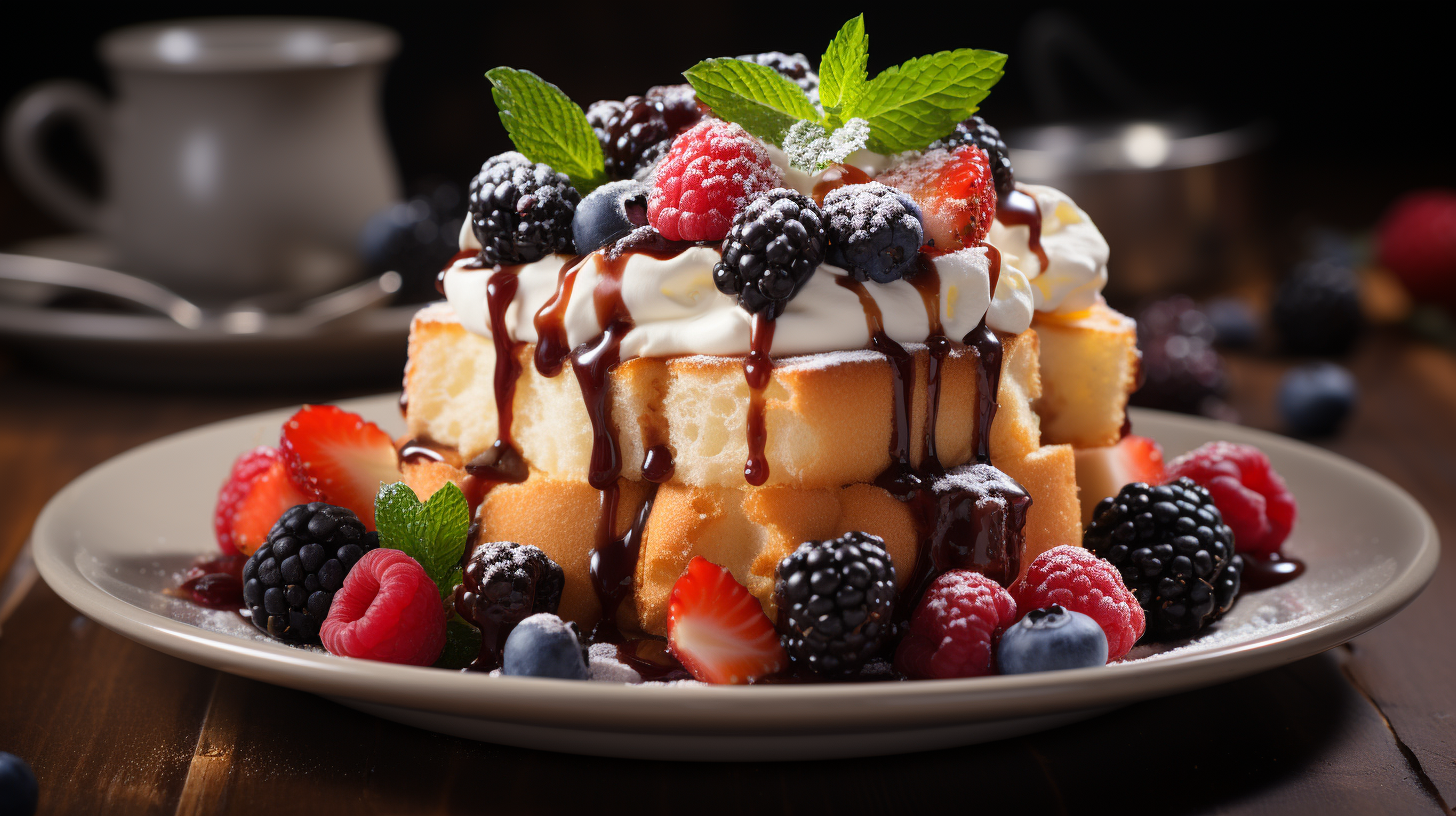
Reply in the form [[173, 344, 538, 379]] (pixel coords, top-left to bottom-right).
[[485, 66, 607, 195]]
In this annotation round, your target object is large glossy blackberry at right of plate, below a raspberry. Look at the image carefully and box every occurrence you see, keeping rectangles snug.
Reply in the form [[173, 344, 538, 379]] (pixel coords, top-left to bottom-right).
[[1083, 476, 1243, 640]]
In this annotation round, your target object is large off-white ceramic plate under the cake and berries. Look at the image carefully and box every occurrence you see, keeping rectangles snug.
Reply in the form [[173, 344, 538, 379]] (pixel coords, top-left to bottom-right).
[[32, 395, 1439, 759]]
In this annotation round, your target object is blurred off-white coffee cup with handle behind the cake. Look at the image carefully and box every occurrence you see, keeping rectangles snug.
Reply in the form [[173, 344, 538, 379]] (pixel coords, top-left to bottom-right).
[[4, 17, 399, 306]]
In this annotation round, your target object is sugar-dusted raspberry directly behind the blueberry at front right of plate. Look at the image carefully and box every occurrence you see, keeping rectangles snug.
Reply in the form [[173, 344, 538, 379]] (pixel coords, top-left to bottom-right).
[[1010, 545, 1146, 660]]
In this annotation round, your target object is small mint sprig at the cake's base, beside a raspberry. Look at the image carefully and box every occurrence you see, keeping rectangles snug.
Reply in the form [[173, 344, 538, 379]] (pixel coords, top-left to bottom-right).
[[374, 482, 470, 600]]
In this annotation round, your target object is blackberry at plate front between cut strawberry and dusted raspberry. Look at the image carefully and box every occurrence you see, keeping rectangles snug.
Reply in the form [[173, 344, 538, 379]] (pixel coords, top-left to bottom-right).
[[773, 532, 895, 675]]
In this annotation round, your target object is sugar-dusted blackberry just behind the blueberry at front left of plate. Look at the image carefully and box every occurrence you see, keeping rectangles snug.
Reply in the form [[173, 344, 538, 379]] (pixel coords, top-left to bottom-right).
[[454, 541, 566, 670]]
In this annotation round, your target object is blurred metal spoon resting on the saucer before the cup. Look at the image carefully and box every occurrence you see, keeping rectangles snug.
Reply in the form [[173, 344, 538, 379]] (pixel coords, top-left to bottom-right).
[[0, 254, 402, 334]]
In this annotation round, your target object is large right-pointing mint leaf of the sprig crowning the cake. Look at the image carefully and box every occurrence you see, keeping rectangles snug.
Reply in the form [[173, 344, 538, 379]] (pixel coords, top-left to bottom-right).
[[844, 48, 1006, 153]]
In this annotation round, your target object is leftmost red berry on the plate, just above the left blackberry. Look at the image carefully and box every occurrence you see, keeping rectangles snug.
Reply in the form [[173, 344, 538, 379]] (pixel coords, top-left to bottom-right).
[[213, 447, 313, 555]]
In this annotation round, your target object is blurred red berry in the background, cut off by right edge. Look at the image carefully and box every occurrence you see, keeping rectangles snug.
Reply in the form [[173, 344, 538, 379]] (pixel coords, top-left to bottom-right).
[[1377, 189, 1456, 309]]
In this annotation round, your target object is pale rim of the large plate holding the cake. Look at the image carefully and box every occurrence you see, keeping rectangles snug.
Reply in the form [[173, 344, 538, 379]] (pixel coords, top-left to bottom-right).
[[31, 393, 1440, 734]]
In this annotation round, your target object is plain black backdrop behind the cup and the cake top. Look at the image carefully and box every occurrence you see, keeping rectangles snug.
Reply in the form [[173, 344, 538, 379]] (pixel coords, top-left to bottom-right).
[[0, 0, 1456, 252]]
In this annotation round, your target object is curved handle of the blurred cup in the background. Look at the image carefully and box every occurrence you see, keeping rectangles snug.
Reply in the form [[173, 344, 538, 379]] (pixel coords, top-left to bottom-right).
[[4, 80, 109, 232]]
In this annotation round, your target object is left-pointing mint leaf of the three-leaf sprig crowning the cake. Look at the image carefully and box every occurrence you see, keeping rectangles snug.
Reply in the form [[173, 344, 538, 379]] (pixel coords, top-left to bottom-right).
[[683, 57, 820, 144]]
